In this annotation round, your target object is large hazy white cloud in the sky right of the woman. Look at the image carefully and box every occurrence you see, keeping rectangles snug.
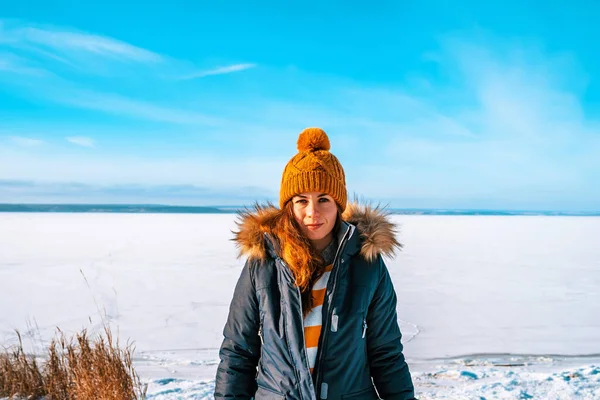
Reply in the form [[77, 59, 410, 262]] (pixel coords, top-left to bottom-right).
[[377, 34, 600, 204]]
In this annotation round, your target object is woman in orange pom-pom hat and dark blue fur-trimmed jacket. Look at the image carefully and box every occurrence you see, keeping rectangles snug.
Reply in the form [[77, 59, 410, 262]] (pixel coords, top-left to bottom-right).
[[215, 128, 414, 400]]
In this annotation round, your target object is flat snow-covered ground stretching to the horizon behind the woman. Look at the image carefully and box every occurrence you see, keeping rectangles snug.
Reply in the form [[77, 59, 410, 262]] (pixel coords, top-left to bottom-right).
[[0, 213, 600, 400]]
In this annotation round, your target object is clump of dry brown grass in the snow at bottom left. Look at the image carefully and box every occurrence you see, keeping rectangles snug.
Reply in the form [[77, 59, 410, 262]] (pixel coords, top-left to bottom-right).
[[0, 328, 146, 400]]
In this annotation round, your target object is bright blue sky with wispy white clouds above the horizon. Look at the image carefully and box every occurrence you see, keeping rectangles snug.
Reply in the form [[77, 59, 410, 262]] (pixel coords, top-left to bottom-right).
[[0, 0, 600, 211]]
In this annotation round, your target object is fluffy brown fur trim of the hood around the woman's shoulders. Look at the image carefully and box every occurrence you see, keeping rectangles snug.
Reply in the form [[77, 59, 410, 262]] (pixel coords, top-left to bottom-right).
[[233, 202, 402, 261]]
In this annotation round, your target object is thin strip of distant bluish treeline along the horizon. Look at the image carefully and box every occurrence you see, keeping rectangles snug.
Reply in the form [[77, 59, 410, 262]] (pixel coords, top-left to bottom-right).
[[0, 203, 600, 216]]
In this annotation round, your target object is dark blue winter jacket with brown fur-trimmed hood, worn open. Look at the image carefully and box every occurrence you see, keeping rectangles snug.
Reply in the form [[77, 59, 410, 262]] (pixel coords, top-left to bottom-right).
[[214, 205, 414, 400]]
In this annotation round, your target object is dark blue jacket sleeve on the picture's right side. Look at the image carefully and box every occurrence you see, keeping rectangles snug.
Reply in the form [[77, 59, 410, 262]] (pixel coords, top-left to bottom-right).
[[367, 257, 415, 400]]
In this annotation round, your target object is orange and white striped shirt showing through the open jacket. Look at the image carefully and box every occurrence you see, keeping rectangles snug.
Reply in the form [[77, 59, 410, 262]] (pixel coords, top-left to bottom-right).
[[304, 264, 333, 374]]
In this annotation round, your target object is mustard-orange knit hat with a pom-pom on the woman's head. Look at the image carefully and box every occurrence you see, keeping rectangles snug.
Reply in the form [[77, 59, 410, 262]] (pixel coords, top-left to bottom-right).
[[279, 128, 348, 211]]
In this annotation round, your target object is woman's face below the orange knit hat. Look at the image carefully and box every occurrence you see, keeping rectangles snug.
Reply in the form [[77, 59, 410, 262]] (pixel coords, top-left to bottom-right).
[[292, 192, 338, 250]]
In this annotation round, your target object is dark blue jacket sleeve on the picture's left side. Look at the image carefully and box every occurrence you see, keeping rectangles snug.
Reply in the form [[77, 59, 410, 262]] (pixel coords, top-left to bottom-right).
[[214, 262, 261, 400]]
